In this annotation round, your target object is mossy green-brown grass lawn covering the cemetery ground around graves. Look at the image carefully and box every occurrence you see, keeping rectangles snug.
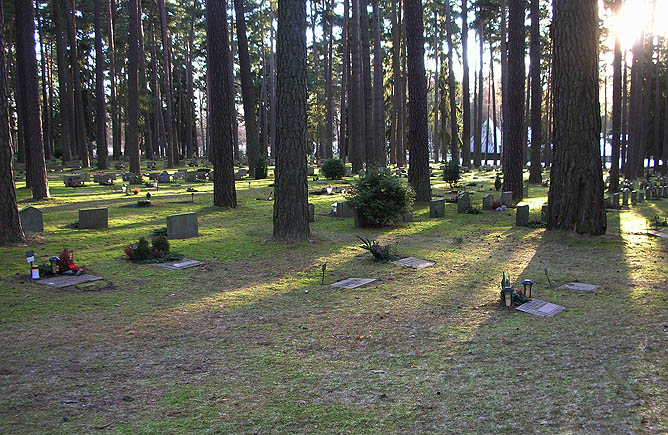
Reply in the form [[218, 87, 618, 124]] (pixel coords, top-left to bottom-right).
[[0, 165, 668, 434]]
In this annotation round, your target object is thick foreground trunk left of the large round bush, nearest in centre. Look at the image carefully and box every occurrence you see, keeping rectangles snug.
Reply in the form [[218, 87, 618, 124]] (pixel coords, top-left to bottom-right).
[[274, 0, 310, 241]]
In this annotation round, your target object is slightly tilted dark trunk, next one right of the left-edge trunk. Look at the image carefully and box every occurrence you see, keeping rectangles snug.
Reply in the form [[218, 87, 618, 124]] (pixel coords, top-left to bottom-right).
[[15, 0, 49, 200]]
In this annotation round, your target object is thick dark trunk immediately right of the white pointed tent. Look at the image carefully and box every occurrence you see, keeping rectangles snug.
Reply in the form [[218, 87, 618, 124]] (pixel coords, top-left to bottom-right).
[[503, 0, 524, 201]]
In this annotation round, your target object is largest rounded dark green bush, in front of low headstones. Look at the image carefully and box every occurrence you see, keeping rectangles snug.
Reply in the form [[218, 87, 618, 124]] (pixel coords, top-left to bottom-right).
[[347, 172, 414, 226]]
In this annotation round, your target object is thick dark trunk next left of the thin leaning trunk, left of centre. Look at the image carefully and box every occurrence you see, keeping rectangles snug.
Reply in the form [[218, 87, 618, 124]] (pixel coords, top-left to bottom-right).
[[206, 0, 237, 208]]
